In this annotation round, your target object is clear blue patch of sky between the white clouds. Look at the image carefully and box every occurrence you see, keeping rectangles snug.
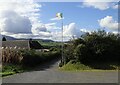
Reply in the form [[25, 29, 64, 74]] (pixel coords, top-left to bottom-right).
[[40, 2, 118, 30]]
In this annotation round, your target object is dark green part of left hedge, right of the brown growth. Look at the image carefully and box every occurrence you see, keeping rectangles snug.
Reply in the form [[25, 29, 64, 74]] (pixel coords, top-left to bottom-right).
[[21, 50, 60, 66]]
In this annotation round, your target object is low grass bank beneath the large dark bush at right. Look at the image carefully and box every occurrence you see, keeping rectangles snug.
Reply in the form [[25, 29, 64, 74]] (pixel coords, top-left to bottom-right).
[[60, 61, 120, 71]]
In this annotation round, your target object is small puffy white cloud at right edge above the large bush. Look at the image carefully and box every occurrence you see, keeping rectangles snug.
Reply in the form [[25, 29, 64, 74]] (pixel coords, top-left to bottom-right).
[[98, 16, 118, 30]]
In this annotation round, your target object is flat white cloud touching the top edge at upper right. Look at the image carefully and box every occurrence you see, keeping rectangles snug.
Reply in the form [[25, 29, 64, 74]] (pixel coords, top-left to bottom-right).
[[82, 0, 117, 10]]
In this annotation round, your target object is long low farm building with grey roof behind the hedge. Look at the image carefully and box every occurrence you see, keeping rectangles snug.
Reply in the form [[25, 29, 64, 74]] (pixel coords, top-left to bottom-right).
[[2, 40, 42, 49]]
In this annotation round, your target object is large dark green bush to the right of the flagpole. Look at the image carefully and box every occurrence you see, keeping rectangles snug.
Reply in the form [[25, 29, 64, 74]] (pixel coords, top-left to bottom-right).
[[62, 30, 120, 69]]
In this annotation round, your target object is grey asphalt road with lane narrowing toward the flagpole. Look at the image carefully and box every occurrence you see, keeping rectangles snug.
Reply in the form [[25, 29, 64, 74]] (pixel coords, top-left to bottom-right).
[[3, 60, 118, 83]]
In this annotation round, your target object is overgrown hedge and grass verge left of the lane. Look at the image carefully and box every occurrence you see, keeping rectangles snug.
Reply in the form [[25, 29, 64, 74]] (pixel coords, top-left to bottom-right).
[[1, 45, 61, 76]]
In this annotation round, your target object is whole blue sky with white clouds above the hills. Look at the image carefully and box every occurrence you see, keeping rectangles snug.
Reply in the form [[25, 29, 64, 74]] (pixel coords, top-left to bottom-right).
[[0, 0, 119, 41]]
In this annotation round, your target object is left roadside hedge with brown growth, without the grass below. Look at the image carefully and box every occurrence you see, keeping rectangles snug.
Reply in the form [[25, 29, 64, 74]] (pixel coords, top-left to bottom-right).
[[2, 49, 61, 66]]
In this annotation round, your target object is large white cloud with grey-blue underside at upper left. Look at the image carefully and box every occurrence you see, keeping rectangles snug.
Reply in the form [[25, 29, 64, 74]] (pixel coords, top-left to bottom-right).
[[0, 0, 40, 33]]
